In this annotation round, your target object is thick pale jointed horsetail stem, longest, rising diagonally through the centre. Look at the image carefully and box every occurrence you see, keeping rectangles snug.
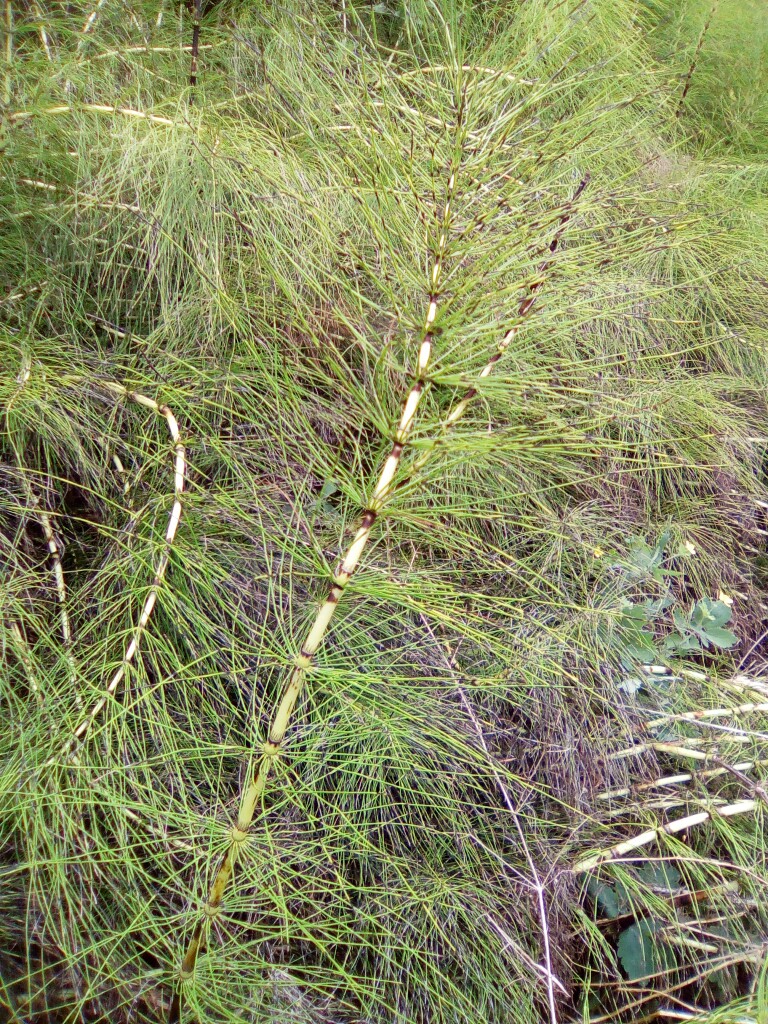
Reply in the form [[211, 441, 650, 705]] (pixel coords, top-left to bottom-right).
[[169, 138, 461, 1024]]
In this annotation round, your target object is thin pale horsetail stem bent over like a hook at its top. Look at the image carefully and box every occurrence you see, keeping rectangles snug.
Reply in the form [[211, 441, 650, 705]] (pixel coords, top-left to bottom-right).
[[46, 381, 186, 767]]
